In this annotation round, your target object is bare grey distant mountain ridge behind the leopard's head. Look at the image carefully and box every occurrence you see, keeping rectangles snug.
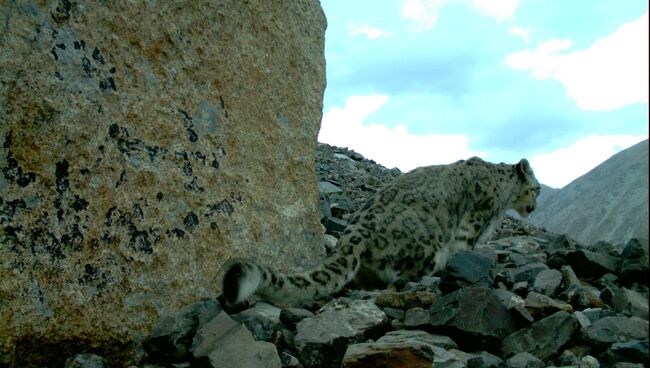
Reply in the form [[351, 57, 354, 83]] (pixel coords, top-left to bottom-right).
[[530, 140, 648, 244]]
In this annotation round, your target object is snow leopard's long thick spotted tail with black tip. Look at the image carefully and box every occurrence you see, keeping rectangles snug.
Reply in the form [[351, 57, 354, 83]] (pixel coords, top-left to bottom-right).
[[222, 247, 360, 306]]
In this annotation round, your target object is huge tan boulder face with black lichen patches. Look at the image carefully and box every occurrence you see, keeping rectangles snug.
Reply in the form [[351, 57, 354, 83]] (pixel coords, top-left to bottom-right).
[[0, 0, 325, 366]]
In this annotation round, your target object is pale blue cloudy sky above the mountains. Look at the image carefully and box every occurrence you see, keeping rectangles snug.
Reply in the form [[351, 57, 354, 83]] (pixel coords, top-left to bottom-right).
[[319, 0, 648, 188]]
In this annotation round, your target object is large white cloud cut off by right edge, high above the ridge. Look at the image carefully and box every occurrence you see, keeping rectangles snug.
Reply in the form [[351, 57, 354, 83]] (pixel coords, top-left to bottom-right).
[[505, 13, 649, 111]]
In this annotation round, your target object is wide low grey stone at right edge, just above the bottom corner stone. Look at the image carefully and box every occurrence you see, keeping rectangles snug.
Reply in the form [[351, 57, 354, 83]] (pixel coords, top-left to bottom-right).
[[581, 317, 648, 345]]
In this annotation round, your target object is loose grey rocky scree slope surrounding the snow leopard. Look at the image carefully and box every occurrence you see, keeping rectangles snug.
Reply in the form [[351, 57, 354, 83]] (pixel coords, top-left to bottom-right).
[[59, 145, 648, 368]]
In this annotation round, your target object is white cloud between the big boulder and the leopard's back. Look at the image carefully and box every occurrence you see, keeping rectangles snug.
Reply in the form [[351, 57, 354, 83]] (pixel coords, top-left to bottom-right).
[[318, 95, 486, 172]]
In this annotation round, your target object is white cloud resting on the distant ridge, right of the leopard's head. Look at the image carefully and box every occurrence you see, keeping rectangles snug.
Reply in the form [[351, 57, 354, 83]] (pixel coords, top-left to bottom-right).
[[530, 135, 648, 188]]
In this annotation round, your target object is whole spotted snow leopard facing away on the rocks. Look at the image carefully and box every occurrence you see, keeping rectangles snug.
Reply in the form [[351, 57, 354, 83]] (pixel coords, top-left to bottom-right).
[[223, 157, 540, 305]]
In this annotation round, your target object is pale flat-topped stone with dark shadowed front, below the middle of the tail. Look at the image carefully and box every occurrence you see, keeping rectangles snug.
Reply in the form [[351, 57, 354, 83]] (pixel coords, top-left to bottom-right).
[[295, 299, 388, 368]]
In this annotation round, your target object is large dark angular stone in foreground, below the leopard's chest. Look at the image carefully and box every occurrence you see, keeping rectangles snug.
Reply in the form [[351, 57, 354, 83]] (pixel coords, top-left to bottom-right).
[[429, 288, 516, 350]]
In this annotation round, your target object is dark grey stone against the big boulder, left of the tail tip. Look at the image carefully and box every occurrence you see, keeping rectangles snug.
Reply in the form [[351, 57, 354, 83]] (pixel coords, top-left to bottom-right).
[[143, 299, 221, 363]]
